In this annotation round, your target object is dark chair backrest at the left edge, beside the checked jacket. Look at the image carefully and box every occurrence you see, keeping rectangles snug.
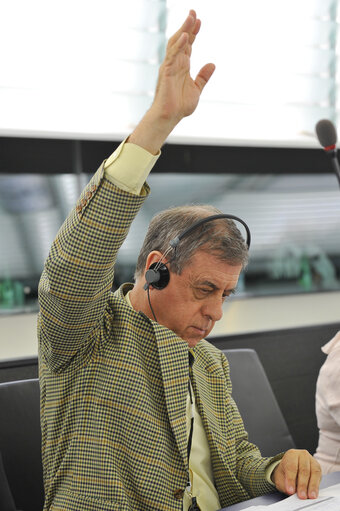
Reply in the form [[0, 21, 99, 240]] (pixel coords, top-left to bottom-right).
[[0, 379, 44, 511]]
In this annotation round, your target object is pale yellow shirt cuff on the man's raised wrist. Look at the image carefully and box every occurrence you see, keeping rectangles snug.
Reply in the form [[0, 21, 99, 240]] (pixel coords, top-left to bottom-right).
[[104, 140, 161, 195]]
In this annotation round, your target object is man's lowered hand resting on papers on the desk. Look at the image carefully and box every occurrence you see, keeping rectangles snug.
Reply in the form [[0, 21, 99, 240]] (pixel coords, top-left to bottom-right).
[[271, 449, 322, 499]]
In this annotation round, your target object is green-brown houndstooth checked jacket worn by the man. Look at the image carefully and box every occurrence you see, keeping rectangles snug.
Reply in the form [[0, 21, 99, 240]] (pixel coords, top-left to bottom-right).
[[38, 162, 282, 511]]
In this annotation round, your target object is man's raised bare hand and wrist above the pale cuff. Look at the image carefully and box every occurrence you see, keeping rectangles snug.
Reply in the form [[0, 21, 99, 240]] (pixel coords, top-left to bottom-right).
[[128, 10, 215, 154]]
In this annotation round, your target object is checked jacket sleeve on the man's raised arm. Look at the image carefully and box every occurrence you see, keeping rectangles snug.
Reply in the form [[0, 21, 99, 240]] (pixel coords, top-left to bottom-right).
[[38, 164, 149, 372]]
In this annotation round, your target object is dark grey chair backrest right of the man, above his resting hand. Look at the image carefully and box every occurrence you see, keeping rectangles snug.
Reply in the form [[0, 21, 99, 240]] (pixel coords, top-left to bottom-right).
[[223, 349, 295, 456]]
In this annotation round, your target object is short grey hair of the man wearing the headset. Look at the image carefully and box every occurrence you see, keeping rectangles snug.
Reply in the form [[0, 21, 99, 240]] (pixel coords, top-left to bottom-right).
[[135, 204, 248, 280]]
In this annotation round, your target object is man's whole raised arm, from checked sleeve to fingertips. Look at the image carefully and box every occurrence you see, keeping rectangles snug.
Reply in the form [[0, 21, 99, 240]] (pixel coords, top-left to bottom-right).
[[38, 11, 214, 371]]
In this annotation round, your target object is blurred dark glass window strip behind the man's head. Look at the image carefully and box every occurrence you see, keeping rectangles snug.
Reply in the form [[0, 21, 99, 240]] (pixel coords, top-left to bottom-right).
[[0, 173, 340, 312]]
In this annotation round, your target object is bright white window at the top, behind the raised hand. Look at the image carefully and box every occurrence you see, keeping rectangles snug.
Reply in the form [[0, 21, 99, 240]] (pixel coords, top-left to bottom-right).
[[0, 0, 339, 146]]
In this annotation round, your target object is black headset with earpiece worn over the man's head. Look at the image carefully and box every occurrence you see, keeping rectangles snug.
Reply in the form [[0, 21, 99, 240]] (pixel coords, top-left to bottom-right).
[[144, 214, 251, 291]]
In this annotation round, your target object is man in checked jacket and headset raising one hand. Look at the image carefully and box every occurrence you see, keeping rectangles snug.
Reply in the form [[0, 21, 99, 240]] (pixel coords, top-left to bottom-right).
[[38, 11, 320, 511]]
